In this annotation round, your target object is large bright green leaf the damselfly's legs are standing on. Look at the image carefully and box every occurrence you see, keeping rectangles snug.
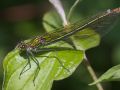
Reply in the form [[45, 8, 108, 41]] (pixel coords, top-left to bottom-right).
[[3, 43, 84, 90]]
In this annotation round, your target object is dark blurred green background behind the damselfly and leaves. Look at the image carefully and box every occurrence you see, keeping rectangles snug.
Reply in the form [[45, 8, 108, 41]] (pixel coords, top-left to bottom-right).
[[0, 0, 120, 90]]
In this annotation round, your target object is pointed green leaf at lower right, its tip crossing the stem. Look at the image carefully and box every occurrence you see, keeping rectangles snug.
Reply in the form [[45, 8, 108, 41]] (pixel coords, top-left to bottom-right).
[[90, 64, 120, 85]]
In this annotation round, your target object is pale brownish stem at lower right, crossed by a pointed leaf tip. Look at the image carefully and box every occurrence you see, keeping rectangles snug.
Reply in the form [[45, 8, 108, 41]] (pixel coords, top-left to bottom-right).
[[84, 57, 104, 90]]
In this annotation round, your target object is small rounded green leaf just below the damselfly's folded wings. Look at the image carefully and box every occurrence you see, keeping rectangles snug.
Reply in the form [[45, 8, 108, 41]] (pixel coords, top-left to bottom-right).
[[72, 28, 100, 50]]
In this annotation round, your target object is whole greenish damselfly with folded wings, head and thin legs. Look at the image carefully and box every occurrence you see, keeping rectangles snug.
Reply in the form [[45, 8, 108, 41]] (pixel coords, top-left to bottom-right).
[[17, 8, 120, 83]]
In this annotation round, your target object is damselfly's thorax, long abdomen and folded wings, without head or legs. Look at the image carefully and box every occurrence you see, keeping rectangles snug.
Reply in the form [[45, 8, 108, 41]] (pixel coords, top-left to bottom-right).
[[21, 8, 120, 49]]
